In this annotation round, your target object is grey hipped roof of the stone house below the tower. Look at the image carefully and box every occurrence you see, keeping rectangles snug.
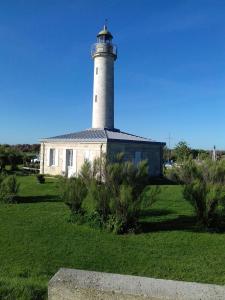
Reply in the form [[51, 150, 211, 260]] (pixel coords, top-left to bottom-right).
[[42, 128, 163, 143]]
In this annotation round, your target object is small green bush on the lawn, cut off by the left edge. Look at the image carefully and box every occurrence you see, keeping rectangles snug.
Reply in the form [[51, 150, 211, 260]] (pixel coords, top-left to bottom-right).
[[0, 175, 19, 203]]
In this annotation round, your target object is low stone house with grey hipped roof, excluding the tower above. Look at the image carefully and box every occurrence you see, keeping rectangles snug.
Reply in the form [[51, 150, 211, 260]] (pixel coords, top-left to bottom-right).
[[40, 129, 165, 177]]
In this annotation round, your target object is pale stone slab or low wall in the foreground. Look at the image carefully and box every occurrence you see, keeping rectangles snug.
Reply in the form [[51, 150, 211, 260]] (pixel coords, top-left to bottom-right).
[[48, 269, 225, 300]]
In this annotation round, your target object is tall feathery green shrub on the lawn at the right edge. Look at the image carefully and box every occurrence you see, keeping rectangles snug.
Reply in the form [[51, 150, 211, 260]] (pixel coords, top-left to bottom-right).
[[179, 161, 225, 228]]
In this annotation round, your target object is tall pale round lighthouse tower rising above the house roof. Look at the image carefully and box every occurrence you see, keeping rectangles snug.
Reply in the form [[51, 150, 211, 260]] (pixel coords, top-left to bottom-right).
[[91, 25, 117, 129]]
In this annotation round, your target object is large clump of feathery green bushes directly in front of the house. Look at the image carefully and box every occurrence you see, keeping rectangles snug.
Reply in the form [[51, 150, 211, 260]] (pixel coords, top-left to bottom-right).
[[60, 156, 159, 233]]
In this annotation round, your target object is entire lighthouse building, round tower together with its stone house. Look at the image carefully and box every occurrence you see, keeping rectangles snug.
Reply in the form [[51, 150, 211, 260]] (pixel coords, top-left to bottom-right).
[[40, 26, 165, 177]]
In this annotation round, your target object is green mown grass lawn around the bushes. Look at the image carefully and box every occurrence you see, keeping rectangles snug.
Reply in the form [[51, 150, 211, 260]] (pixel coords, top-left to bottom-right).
[[0, 176, 225, 299]]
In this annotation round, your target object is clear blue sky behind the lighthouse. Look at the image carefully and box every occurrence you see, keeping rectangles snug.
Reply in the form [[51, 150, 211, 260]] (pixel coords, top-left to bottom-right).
[[0, 0, 225, 150]]
